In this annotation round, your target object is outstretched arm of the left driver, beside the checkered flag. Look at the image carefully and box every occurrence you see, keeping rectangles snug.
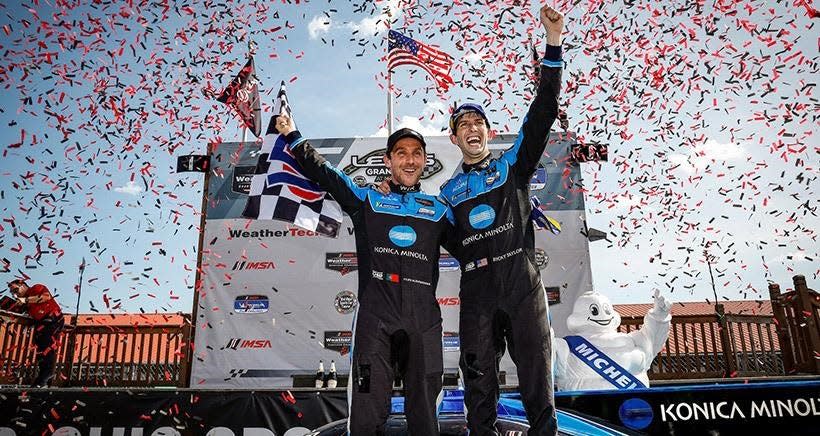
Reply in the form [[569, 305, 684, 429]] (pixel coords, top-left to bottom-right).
[[276, 114, 367, 214]]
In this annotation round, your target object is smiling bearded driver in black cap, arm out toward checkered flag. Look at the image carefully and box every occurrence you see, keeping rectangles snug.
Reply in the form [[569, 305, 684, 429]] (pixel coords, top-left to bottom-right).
[[276, 113, 453, 436]]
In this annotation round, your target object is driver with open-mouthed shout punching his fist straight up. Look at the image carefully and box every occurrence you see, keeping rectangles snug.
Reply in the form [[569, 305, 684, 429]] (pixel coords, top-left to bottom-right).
[[440, 6, 563, 436]]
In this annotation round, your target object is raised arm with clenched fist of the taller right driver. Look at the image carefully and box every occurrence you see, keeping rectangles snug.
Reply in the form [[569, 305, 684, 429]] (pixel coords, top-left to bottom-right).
[[502, 6, 564, 177]]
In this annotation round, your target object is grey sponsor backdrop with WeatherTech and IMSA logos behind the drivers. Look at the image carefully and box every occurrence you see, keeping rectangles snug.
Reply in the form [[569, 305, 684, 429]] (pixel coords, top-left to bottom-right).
[[191, 133, 592, 388]]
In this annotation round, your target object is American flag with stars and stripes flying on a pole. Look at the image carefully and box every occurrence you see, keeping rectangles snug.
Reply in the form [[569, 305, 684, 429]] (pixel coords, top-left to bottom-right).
[[387, 30, 454, 91]]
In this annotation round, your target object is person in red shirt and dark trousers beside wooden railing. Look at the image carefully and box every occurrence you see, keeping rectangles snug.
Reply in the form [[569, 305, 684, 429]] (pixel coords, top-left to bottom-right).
[[9, 279, 65, 387]]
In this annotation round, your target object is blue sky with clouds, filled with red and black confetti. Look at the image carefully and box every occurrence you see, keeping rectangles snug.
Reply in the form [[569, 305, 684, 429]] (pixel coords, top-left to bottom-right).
[[0, 0, 820, 313]]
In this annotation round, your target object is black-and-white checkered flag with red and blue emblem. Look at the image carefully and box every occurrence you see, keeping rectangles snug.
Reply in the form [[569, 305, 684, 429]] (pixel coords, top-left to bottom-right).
[[242, 82, 342, 238]]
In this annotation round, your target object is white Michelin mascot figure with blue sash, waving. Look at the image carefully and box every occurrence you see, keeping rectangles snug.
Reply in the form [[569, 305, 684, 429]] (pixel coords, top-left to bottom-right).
[[552, 290, 672, 391]]
